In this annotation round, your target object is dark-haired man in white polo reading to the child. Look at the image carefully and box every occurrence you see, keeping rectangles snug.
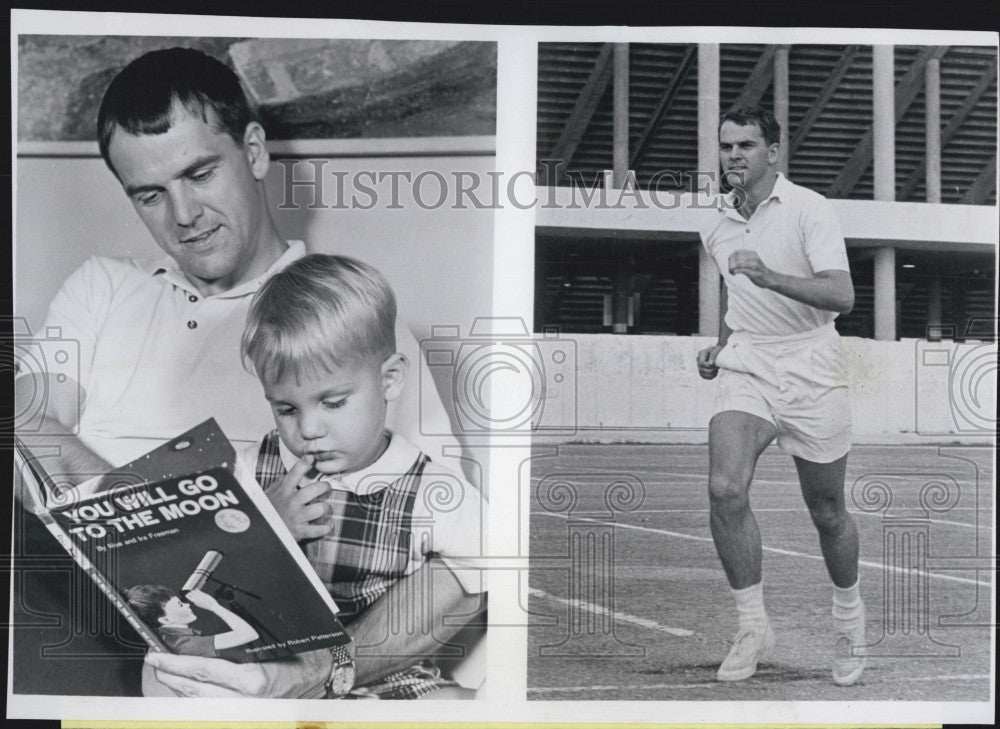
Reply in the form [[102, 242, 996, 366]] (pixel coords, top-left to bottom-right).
[[13, 48, 479, 696]]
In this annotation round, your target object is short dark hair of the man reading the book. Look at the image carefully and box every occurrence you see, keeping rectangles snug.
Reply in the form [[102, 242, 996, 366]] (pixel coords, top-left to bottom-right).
[[97, 48, 257, 175]]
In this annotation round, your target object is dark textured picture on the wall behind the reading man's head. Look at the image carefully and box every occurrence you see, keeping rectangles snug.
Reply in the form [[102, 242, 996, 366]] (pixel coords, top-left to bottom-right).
[[17, 35, 496, 141]]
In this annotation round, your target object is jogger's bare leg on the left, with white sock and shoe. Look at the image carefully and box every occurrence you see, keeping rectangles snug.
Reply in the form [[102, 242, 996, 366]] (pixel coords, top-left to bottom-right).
[[708, 411, 776, 681]]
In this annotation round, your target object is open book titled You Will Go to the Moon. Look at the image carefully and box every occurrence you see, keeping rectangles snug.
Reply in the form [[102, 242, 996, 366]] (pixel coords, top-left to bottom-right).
[[15, 419, 350, 663]]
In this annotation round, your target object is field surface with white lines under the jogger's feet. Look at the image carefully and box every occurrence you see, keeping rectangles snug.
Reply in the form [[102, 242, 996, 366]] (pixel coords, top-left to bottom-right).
[[528, 445, 995, 701]]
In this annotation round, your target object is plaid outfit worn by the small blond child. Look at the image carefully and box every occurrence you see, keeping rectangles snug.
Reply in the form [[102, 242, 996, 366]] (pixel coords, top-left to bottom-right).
[[255, 430, 457, 699]]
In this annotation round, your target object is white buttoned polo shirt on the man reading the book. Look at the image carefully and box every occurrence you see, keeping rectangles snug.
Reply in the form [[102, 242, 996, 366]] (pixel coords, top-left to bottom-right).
[[37, 241, 457, 467]]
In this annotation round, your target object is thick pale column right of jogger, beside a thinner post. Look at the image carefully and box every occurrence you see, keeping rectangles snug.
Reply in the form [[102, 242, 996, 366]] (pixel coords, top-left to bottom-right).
[[876, 46, 896, 342]]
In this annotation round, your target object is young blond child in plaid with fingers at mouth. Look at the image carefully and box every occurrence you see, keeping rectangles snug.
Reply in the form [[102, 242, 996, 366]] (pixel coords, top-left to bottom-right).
[[240, 254, 485, 698]]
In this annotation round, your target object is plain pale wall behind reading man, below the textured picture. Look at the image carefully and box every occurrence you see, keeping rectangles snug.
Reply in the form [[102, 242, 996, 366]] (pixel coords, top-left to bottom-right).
[[14, 151, 494, 338]]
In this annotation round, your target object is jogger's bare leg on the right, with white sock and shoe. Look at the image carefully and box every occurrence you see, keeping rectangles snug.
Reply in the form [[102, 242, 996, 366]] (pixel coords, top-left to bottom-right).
[[795, 455, 866, 686]]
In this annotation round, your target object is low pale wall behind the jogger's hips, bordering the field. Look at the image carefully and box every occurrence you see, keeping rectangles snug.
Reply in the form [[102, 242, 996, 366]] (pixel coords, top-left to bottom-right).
[[540, 334, 997, 443]]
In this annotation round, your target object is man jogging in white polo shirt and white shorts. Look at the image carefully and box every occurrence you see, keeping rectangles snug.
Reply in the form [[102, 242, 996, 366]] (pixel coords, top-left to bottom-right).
[[698, 107, 865, 686]]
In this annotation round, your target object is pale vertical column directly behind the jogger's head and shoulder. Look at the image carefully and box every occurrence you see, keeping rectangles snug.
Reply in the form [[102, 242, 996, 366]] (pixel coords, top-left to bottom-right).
[[696, 43, 722, 337]]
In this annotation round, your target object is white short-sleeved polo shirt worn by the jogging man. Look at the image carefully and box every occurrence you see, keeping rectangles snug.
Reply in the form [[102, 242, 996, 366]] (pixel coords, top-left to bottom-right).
[[702, 174, 850, 336]]
